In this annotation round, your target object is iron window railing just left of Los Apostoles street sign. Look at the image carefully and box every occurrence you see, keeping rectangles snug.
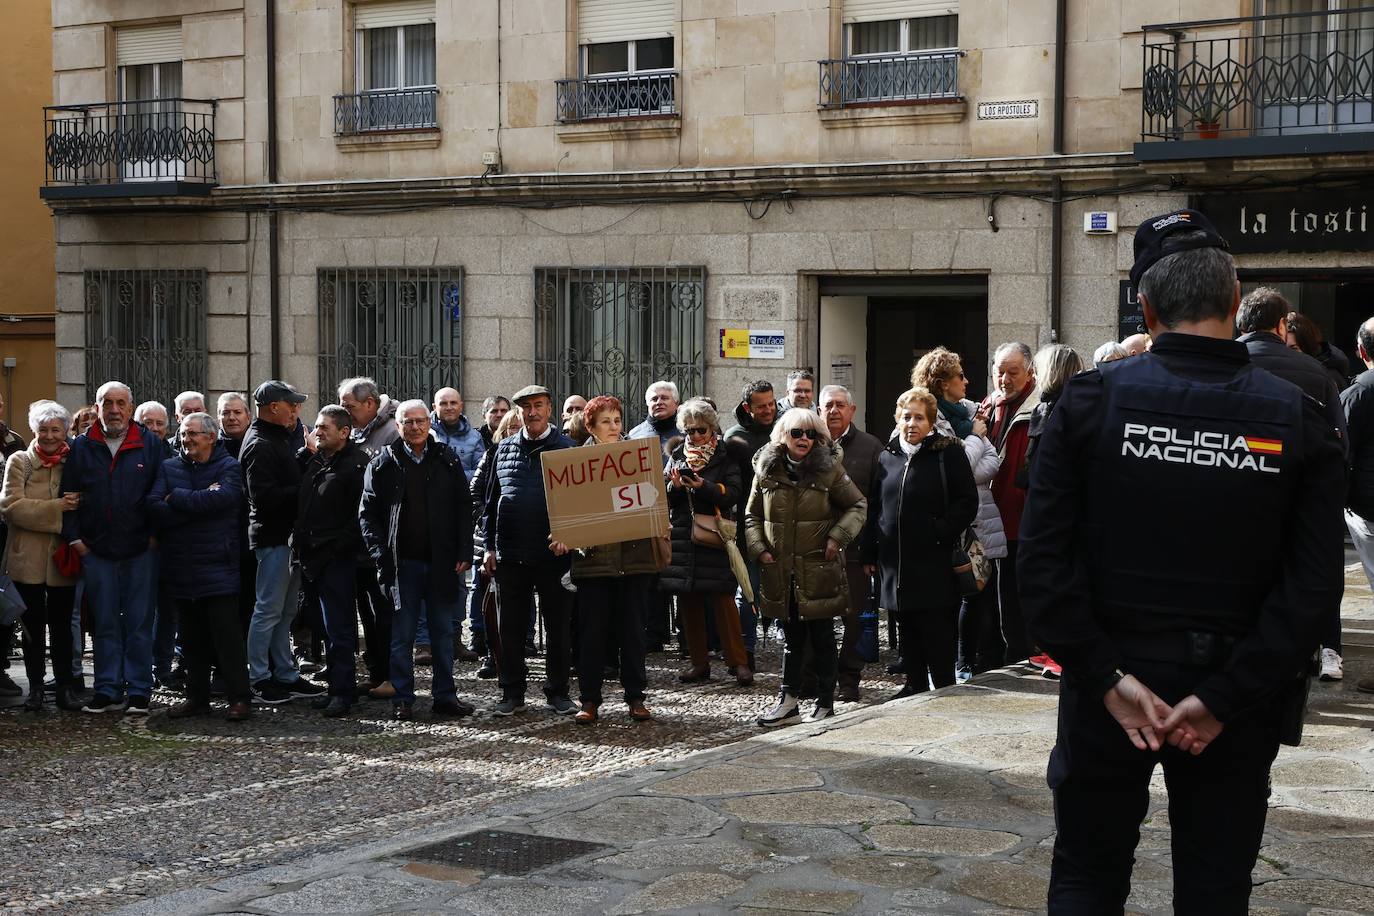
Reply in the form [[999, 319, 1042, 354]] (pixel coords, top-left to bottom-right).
[[820, 51, 963, 108]]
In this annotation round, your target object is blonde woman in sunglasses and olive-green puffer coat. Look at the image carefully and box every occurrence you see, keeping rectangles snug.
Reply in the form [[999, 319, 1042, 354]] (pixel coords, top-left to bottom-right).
[[745, 408, 868, 728]]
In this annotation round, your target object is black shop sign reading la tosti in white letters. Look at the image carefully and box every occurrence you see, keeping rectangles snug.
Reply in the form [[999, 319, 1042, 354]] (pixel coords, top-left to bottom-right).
[[1193, 191, 1374, 254]]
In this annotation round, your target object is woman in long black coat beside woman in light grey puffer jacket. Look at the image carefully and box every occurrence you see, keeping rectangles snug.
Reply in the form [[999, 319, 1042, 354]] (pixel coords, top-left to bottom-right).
[[863, 389, 978, 698]]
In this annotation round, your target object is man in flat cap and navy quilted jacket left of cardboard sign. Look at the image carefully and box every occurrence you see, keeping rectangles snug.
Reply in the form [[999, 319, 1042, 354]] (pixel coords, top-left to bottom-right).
[[478, 385, 577, 715]]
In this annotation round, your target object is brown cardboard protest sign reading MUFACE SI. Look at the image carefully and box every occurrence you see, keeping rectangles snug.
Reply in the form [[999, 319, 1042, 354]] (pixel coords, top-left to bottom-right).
[[540, 437, 668, 547]]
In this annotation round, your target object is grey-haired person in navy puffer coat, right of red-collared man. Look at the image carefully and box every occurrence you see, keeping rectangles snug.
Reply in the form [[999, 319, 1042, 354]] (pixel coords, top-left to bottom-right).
[[147, 412, 253, 722]]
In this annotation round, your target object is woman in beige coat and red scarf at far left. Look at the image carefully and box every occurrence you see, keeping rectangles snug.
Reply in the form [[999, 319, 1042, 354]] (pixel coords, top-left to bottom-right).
[[0, 401, 85, 713]]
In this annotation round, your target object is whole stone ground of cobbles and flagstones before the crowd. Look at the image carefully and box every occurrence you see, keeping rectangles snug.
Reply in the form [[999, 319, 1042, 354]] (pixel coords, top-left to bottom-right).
[[0, 567, 1374, 916]]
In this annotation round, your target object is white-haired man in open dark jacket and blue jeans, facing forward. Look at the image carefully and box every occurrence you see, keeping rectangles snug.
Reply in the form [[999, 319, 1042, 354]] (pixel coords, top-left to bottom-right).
[[360, 400, 474, 721]]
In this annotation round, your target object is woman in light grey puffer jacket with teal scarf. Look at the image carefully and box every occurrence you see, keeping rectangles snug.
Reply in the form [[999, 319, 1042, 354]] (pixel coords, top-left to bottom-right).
[[911, 346, 1007, 681]]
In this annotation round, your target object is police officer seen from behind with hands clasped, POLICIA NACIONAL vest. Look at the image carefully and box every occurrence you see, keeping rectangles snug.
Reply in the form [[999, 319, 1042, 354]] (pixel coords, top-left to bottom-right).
[[1018, 210, 1344, 915]]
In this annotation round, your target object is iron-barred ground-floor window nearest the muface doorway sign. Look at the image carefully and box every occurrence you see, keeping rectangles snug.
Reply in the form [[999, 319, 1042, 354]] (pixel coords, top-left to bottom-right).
[[534, 266, 706, 431]]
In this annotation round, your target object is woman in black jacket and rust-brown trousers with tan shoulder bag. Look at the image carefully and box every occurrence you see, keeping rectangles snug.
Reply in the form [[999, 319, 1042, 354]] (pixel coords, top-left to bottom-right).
[[658, 398, 754, 687]]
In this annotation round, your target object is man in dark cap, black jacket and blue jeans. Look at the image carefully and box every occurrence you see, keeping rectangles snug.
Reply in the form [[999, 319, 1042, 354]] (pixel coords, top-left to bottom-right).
[[239, 379, 324, 705]]
